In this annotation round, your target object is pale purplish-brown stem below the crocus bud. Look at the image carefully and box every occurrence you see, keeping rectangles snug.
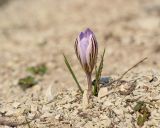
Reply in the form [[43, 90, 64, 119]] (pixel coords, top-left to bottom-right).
[[86, 73, 92, 100]]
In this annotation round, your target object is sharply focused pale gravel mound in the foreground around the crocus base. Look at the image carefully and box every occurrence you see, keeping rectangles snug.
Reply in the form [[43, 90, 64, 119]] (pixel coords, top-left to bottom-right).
[[0, 71, 160, 128]]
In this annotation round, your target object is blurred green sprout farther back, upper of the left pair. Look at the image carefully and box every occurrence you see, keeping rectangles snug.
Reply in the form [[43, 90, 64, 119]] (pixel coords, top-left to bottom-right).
[[27, 64, 48, 75]]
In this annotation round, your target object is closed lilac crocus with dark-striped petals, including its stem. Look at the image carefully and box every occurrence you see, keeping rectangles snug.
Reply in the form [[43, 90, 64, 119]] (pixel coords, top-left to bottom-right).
[[75, 28, 98, 96]]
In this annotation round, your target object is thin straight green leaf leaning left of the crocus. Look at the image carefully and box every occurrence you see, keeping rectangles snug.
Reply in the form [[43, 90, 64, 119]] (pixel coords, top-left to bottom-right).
[[63, 54, 83, 94]]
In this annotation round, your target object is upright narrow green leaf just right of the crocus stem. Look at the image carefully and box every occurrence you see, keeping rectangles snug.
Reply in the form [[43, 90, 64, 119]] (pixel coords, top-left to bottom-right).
[[93, 49, 105, 96]]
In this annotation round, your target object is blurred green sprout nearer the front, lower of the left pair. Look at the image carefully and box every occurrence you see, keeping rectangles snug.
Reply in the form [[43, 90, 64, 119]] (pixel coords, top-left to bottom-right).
[[18, 76, 38, 90]]
